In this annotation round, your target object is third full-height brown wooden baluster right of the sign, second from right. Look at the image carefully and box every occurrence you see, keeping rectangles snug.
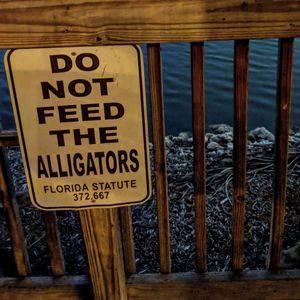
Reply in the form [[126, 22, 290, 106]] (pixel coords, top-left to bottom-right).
[[232, 40, 249, 271]]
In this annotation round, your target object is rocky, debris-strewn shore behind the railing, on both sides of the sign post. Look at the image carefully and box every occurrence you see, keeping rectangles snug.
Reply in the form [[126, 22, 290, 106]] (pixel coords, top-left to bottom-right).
[[0, 124, 300, 274]]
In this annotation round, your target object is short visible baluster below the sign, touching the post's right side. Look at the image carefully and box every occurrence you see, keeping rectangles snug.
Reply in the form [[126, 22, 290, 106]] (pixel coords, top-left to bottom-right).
[[120, 207, 136, 274]]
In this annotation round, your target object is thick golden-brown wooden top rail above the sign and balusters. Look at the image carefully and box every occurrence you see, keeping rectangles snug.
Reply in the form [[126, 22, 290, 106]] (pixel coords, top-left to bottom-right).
[[0, 0, 300, 48]]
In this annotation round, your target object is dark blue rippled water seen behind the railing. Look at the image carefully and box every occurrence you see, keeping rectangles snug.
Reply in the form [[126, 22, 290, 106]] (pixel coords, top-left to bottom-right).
[[0, 39, 300, 134]]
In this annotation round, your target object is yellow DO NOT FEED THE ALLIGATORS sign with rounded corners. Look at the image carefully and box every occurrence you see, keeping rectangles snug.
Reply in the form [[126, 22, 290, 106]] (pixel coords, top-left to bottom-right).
[[6, 45, 151, 210]]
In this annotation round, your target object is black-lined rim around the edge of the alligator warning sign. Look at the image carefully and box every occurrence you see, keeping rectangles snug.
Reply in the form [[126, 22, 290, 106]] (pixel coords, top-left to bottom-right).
[[6, 45, 152, 211]]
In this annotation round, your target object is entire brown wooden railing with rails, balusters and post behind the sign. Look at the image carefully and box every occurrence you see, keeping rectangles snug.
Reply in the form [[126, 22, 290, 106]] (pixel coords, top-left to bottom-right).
[[0, 0, 300, 300]]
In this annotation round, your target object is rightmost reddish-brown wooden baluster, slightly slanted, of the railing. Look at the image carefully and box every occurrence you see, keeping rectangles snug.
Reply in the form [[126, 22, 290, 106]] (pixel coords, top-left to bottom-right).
[[269, 39, 294, 269]]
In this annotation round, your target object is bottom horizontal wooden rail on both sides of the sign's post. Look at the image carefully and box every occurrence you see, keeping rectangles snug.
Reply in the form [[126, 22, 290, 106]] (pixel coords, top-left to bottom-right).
[[0, 270, 300, 300]]
